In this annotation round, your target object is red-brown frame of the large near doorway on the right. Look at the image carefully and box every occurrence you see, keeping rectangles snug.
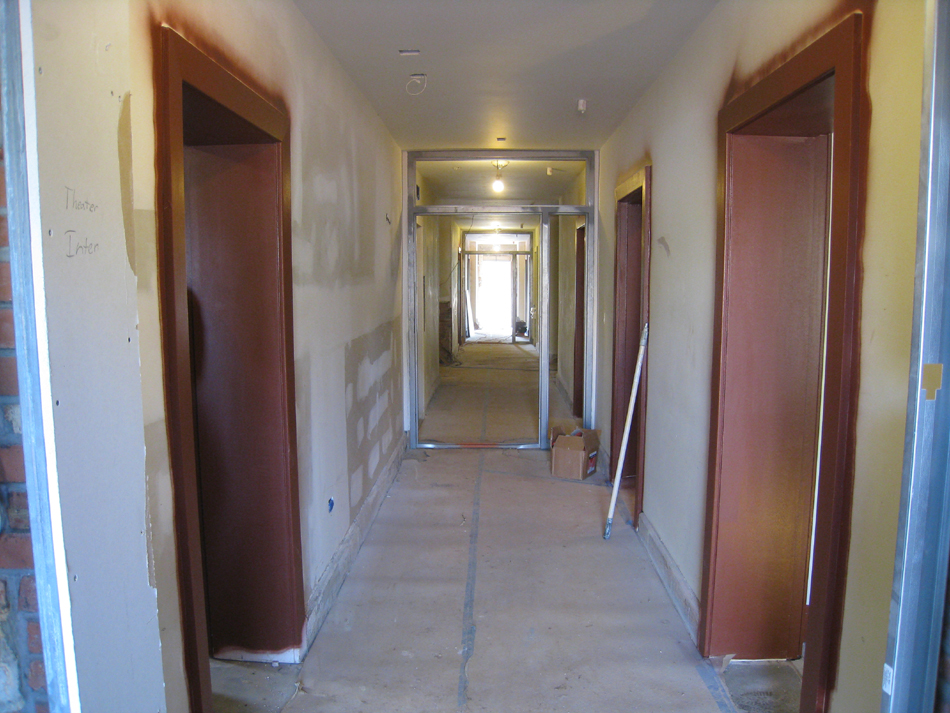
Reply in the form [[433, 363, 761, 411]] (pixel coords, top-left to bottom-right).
[[699, 13, 868, 713]]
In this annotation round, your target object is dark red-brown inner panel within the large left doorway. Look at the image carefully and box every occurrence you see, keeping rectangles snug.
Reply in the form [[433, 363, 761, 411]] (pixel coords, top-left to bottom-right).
[[184, 143, 303, 655]]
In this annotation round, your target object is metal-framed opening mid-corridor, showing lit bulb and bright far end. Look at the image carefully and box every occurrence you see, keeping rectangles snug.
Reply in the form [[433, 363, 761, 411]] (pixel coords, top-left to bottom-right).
[[406, 151, 593, 448]]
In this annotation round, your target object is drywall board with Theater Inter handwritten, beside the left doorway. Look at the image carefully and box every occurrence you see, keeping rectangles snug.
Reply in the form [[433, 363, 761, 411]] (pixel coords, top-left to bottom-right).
[[23, 0, 168, 711]]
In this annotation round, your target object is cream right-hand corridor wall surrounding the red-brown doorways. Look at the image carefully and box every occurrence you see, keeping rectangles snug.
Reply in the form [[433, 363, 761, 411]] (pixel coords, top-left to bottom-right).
[[597, 0, 924, 713]]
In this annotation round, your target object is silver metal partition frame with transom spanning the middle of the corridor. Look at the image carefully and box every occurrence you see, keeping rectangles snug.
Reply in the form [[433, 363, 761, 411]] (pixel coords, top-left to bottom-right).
[[403, 150, 599, 449]]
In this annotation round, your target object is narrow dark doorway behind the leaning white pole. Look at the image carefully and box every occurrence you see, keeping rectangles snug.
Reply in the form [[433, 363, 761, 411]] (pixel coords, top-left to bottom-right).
[[610, 166, 652, 527]]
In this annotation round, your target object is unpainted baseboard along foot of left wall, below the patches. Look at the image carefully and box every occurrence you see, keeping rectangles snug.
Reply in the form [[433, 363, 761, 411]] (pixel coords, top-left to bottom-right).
[[296, 433, 408, 663]]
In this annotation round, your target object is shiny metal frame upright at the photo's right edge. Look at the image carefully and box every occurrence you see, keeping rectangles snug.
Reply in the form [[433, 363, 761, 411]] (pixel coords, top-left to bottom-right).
[[881, 0, 950, 713]]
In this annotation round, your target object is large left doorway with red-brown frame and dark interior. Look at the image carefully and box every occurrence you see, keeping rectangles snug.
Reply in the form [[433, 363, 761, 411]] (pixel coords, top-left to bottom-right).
[[159, 28, 304, 711]]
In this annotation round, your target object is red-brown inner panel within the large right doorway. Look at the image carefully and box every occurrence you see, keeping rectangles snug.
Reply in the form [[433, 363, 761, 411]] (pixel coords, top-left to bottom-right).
[[708, 135, 830, 659]]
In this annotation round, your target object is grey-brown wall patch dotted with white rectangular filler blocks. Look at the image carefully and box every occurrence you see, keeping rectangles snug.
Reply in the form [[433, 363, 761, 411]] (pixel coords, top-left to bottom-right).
[[344, 320, 402, 520]]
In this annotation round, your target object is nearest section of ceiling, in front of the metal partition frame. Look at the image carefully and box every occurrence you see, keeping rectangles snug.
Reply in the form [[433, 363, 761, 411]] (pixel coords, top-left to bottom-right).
[[296, 0, 715, 150]]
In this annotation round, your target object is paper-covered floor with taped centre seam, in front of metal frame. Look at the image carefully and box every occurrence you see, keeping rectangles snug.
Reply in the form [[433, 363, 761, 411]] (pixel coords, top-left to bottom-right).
[[284, 450, 734, 713]]
